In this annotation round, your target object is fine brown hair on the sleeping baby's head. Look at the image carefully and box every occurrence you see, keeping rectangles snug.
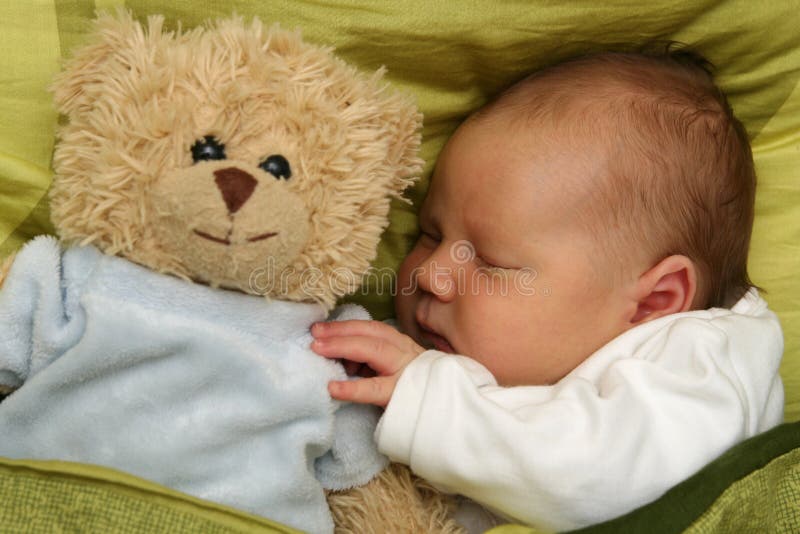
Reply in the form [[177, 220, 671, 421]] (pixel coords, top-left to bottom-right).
[[481, 45, 756, 309]]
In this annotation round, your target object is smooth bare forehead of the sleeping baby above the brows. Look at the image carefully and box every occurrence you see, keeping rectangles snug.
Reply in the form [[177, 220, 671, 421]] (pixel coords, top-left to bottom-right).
[[422, 121, 606, 230]]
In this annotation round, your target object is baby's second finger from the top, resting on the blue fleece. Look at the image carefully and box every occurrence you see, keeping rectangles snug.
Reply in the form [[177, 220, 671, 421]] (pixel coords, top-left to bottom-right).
[[311, 336, 404, 374]]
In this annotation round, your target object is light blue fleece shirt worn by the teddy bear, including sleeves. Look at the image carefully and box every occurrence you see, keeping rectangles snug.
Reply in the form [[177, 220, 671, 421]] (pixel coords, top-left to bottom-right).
[[0, 237, 386, 532]]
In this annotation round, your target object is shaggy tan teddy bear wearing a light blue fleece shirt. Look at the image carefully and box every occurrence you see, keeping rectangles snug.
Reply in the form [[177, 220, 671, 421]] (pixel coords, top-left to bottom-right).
[[0, 12, 468, 532]]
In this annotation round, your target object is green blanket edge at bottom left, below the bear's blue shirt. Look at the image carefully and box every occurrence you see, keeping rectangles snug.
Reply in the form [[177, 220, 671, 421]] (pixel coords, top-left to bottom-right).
[[0, 459, 299, 534]]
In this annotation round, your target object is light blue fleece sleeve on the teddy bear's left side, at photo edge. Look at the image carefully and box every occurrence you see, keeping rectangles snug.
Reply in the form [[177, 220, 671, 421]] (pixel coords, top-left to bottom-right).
[[0, 236, 85, 388]]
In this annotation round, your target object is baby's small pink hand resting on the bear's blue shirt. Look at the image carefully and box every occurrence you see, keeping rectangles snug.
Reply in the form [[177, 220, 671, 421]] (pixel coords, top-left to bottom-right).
[[311, 321, 425, 407]]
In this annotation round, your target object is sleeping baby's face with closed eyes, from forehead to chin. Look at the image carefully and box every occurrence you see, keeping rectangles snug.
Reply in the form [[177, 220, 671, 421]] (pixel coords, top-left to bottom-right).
[[396, 121, 624, 386]]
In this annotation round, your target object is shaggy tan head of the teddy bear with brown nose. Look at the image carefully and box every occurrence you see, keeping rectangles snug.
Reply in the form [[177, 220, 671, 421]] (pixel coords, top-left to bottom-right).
[[50, 12, 421, 307]]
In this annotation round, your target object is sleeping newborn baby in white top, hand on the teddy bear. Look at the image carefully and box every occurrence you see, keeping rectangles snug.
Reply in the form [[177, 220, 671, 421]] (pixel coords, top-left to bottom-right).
[[312, 52, 783, 530]]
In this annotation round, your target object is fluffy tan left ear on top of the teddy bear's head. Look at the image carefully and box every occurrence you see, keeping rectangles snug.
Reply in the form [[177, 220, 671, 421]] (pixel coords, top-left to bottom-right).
[[50, 9, 157, 116]]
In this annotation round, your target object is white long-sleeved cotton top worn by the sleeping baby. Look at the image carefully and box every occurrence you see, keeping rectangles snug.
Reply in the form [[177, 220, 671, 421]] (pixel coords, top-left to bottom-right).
[[376, 312, 780, 530]]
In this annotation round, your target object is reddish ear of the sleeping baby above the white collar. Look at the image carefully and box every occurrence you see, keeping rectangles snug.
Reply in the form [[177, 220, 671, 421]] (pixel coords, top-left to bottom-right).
[[630, 255, 697, 325]]
